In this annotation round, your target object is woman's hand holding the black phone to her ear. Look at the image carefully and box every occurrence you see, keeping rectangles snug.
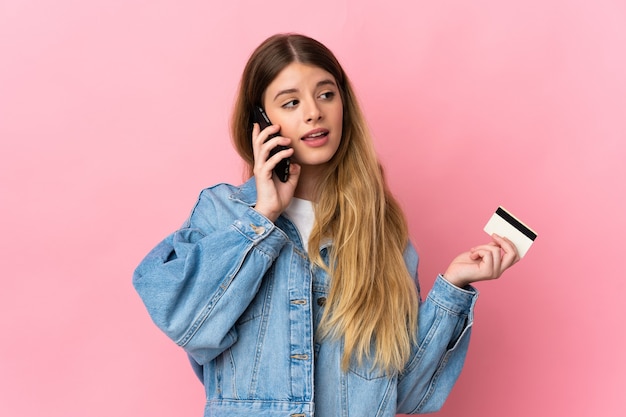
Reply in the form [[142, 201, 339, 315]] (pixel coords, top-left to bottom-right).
[[252, 123, 300, 222]]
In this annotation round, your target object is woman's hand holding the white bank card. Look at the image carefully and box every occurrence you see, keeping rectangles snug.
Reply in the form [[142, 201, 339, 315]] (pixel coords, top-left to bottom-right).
[[443, 233, 520, 288]]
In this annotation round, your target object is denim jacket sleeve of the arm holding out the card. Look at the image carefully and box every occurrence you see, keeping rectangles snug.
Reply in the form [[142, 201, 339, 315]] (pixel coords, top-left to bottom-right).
[[397, 275, 478, 414]]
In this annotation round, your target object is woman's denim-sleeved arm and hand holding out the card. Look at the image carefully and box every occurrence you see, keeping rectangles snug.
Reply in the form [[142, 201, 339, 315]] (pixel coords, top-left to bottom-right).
[[398, 235, 519, 414]]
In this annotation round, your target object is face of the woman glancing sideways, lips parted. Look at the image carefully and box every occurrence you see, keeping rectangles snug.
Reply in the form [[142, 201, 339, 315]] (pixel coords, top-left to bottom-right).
[[263, 62, 343, 173]]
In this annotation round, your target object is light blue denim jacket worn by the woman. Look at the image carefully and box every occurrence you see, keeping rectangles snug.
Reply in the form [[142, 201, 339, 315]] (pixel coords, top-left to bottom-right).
[[133, 179, 478, 417]]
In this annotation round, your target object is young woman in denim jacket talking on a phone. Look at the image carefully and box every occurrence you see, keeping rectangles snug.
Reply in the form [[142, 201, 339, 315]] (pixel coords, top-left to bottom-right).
[[133, 34, 519, 417]]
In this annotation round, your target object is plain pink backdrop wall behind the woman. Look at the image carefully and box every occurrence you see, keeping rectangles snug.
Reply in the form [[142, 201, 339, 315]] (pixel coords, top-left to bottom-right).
[[0, 0, 626, 417]]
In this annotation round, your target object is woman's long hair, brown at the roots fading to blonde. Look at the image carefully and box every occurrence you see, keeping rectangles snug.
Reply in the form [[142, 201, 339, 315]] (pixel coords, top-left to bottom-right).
[[231, 34, 418, 373]]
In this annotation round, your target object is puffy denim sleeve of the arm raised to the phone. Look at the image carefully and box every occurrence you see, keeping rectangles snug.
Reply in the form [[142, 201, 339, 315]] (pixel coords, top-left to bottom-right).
[[133, 190, 287, 364]]
